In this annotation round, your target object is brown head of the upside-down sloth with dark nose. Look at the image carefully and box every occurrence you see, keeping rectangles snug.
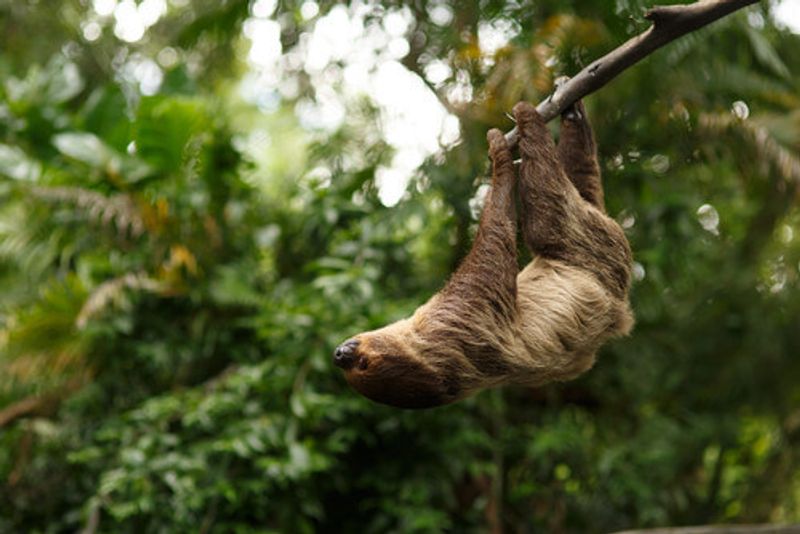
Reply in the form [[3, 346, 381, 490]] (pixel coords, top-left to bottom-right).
[[333, 327, 458, 408]]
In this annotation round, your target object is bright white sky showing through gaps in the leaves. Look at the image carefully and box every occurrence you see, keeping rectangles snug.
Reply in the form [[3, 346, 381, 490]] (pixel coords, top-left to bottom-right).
[[104, 0, 800, 206]]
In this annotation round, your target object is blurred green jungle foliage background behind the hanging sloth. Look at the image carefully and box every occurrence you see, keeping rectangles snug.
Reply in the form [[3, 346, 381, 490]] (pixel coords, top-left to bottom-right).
[[0, 0, 800, 533]]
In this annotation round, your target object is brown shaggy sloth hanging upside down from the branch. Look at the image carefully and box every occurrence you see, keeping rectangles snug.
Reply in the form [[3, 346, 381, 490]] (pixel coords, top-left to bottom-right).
[[334, 102, 633, 408]]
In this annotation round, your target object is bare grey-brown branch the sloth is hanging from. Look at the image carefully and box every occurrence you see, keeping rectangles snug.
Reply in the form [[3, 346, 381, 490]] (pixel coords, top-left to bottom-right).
[[506, 0, 758, 146]]
